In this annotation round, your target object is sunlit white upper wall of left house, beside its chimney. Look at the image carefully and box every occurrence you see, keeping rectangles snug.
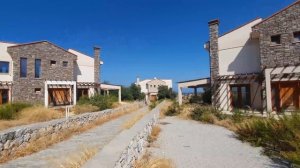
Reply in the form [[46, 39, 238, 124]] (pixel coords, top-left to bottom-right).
[[68, 49, 95, 82]]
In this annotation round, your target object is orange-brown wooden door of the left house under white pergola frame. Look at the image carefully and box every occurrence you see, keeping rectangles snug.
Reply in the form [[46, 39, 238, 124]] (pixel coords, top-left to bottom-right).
[[49, 88, 71, 106]]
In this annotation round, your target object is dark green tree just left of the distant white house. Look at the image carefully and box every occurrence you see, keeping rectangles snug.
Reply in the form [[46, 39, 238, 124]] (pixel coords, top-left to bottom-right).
[[121, 83, 145, 101]]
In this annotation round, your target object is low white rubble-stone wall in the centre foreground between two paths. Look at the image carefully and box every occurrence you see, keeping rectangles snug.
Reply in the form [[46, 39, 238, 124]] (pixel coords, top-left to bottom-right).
[[115, 115, 157, 168]]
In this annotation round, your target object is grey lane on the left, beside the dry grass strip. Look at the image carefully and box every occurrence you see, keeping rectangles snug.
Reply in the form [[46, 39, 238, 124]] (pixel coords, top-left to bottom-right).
[[0, 107, 148, 168]]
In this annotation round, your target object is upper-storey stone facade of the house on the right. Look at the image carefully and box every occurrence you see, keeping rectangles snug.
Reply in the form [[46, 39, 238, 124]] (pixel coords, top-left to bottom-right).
[[253, 1, 300, 70]]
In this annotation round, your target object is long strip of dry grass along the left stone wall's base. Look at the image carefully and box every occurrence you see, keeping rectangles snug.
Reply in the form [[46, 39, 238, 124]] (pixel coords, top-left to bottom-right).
[[0, 103, 141, 163]]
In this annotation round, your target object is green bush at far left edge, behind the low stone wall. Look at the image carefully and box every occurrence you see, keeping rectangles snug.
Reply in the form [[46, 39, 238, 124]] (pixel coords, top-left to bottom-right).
[[0, 103, 31, 120]]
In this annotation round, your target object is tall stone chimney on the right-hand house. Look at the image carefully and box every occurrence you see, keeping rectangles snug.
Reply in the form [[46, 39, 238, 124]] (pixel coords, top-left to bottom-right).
[[208, 20, 219, 107]]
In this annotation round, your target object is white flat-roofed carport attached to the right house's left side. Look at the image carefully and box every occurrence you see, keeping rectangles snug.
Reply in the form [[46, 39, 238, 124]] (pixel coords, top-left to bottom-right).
[[178, 78, 210, 105]]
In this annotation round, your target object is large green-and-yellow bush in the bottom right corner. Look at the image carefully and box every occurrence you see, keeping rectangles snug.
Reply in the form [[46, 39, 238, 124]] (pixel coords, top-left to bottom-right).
[[236, 114, 300, 164]]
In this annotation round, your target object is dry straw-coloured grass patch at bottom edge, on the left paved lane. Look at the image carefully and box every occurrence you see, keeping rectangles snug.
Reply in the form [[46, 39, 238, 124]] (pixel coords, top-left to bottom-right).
[[56, 147, 98, 168]]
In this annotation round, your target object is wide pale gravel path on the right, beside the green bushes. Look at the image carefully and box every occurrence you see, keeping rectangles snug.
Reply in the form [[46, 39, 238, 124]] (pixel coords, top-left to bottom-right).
[[150, 117, 283, 168]]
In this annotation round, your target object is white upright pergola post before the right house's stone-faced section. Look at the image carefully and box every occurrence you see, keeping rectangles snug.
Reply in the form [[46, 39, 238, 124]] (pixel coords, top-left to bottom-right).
[[265, 69, 272, 112]]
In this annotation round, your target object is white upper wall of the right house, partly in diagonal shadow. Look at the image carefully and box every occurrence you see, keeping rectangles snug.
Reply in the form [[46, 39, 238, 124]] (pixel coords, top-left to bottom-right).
[[219, 19, 261, 75]]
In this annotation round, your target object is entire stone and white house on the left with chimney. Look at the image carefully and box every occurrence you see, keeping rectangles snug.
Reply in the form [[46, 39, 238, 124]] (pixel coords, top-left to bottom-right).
[[0, 41, 121, 107]]
